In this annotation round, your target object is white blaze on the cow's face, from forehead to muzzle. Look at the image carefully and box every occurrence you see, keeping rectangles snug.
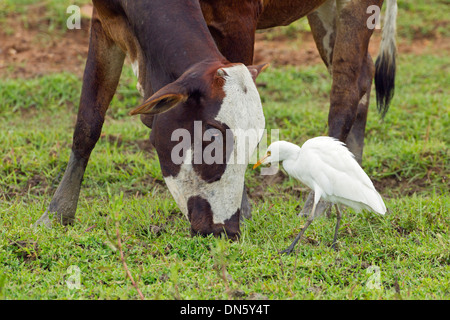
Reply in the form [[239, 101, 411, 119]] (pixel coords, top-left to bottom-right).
[[165, 64, 265, 224]]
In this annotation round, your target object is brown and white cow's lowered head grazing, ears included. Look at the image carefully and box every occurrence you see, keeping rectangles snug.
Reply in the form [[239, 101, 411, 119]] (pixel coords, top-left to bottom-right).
[[131, 63, 265, 239]]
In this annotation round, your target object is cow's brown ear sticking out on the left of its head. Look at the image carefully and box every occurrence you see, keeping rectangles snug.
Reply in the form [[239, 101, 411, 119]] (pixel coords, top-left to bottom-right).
[[129, 82, 189, 115]]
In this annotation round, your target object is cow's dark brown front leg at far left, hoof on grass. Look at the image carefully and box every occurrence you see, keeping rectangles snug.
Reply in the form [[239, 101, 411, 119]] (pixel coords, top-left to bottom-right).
[[35, 9, 125, 226]]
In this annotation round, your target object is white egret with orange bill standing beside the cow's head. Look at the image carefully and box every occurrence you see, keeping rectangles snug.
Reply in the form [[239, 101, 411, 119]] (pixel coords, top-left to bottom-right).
[[253, 137, 386, 254]]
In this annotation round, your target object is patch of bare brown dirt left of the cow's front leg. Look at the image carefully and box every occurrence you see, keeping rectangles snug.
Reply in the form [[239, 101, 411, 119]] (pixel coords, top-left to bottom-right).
[[0, 8, 89, 78]]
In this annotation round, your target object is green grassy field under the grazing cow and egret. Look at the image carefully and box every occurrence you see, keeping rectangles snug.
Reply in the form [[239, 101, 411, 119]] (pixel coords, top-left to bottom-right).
[[0, 0, 450, 299]]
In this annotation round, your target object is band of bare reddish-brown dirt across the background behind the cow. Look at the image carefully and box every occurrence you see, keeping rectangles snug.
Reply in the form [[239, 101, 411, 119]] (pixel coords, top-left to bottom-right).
[[0, 5, 450, 78]]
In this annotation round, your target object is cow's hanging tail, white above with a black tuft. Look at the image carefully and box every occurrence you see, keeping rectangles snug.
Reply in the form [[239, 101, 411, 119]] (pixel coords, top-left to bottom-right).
[[375, 0, 397, 118]]
